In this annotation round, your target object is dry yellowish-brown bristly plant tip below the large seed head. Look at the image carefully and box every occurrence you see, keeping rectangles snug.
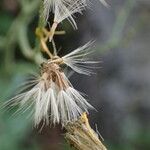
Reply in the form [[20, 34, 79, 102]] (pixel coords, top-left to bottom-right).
[[65, 113, 107, 150]]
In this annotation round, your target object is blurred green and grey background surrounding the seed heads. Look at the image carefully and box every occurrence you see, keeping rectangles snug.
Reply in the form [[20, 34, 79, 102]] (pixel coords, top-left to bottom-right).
[[0, 0, 150, 150]]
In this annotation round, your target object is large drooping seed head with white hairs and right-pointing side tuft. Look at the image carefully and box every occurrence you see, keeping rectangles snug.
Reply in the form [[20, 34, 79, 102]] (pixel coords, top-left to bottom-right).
[[2, 42, 94, 127]]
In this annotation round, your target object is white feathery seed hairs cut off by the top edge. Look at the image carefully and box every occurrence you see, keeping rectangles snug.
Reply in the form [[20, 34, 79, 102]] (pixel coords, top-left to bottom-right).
[[44, 0, 87, 28]]
